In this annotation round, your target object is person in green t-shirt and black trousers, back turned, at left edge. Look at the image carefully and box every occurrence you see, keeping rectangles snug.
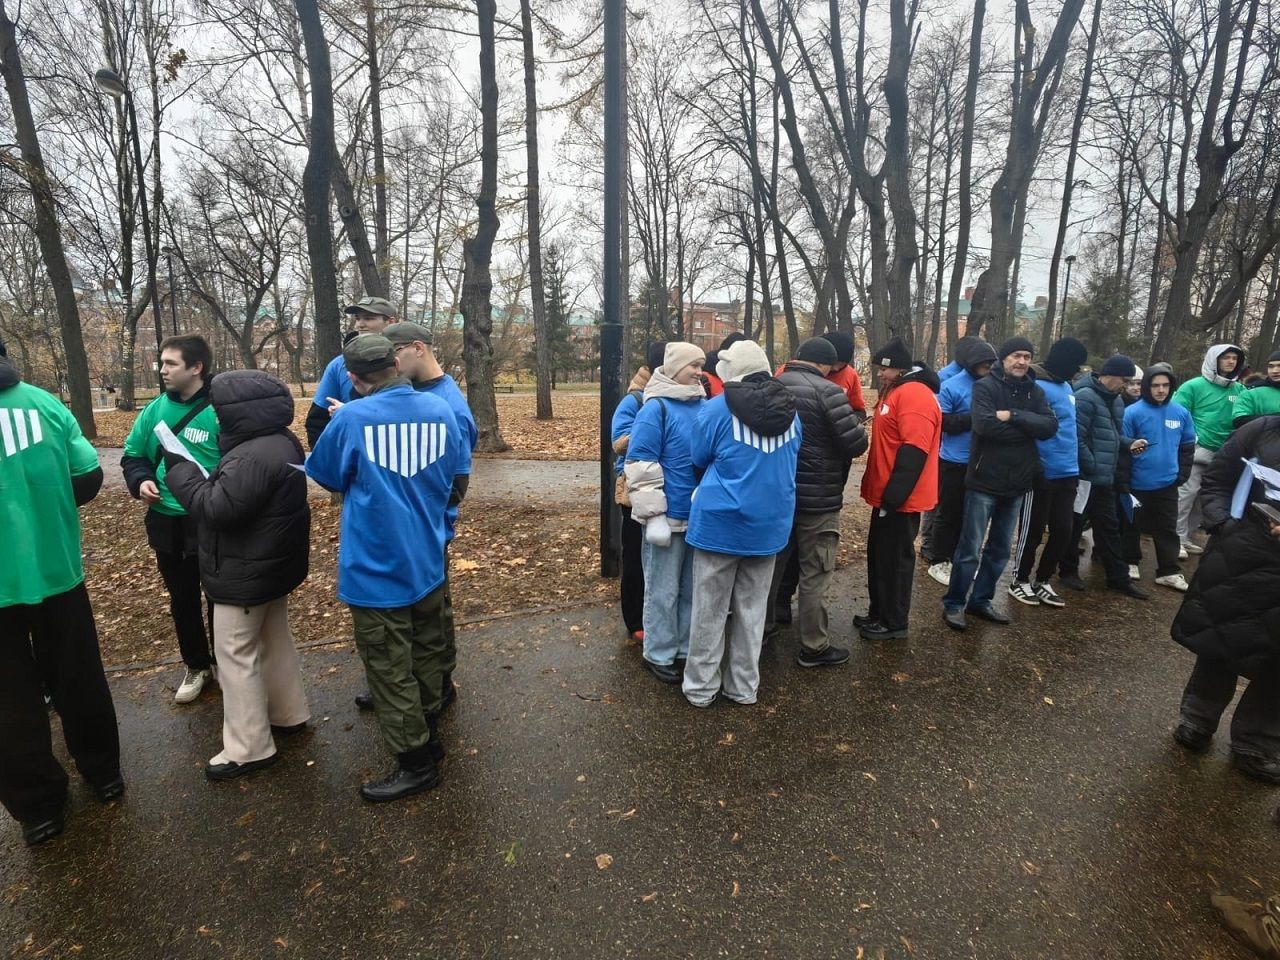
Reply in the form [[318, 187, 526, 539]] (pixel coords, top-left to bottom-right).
[[0, 343, 124, 845]]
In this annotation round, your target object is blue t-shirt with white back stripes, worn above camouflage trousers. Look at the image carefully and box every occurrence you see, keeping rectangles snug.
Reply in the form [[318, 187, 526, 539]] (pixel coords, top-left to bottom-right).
[[307, 380, 465, 609]]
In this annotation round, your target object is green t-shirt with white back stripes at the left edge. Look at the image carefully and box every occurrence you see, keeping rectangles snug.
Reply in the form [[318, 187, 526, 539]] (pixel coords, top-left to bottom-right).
[[0, 383, 97, 607]]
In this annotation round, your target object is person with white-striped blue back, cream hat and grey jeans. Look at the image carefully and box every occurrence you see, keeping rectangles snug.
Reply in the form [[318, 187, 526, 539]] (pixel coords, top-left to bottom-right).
[[684, 340, 801, 707]]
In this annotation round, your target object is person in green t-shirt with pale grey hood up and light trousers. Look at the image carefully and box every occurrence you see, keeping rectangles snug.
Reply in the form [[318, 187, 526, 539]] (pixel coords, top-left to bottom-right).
[[1174, 343, 1244, 559]]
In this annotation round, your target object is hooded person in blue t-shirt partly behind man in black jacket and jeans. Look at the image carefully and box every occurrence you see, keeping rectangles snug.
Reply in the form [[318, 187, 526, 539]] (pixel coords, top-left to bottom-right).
[[925, 337, 996, 586]]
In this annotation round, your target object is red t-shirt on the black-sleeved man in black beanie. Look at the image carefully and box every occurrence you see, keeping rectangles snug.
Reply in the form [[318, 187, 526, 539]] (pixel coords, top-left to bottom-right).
[[863, 369, 942, 513]]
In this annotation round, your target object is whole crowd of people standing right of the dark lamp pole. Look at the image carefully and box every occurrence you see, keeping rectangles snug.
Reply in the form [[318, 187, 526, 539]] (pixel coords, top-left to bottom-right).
[[612, 334, 1280, 783]]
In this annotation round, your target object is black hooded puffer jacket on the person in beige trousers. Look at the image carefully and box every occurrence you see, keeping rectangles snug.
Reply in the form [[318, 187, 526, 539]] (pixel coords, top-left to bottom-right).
[[165, 370, 311, 607]]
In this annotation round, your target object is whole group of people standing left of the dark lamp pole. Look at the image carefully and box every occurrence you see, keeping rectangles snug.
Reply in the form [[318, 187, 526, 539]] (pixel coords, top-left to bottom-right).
[[0, 297, 477, 844]]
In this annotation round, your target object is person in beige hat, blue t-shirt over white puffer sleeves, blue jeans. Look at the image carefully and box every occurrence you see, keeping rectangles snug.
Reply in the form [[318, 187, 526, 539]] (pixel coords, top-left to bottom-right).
[[625, 340, 707, 684]]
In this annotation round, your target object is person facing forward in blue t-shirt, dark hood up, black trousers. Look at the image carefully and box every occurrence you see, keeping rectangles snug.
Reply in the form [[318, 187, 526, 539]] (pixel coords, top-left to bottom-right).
[[1124, 365, 1196, 591]]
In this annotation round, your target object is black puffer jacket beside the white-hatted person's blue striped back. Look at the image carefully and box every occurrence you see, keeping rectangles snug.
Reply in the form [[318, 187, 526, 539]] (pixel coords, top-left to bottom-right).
[[777, 361, 867, 513]]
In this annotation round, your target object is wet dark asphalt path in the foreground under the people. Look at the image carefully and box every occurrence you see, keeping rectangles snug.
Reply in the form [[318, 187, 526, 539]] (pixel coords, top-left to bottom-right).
[[0, 571, 1280, 960]]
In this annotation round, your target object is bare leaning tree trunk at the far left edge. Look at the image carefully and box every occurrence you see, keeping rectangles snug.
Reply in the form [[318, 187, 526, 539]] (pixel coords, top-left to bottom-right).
[[0, 0, 97, 439]]
